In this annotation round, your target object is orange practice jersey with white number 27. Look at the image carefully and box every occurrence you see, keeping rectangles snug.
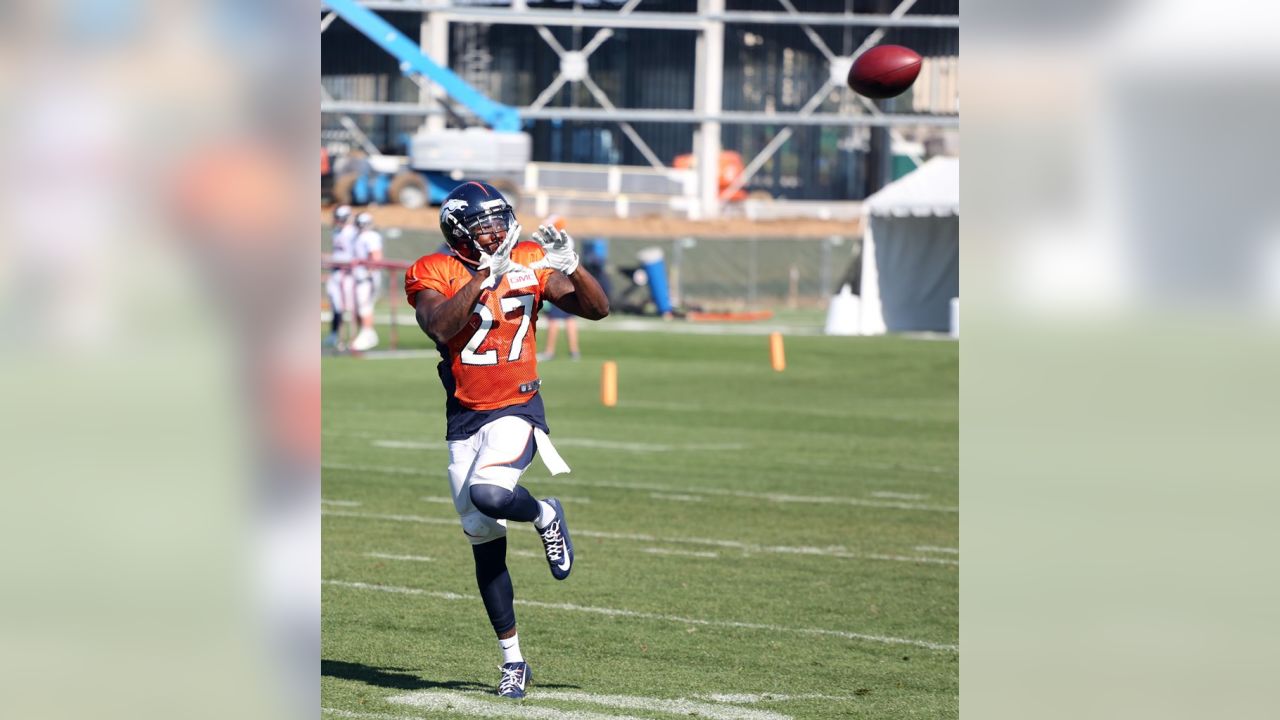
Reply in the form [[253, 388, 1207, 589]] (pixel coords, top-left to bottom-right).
[[404, 242, 552, 410]]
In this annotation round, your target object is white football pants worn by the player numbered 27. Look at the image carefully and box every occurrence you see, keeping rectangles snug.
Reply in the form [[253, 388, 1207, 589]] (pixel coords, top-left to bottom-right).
[[449, 416, 535, 544]]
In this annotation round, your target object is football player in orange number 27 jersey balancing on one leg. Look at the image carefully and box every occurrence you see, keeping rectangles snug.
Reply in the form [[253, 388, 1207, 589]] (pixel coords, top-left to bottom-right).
[[404, 182, 609, 698]]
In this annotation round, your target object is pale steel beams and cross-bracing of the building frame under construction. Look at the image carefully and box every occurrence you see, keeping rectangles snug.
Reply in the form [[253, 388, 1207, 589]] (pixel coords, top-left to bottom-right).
[[321, 0, 960, 217]]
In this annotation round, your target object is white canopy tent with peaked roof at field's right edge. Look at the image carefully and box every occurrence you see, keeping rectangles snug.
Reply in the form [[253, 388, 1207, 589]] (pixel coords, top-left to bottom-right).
[[859, 158, 960, 334]]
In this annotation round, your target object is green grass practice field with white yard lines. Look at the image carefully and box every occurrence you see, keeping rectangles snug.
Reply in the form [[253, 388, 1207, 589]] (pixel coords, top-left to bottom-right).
[[323, 330, 960, 720]]
